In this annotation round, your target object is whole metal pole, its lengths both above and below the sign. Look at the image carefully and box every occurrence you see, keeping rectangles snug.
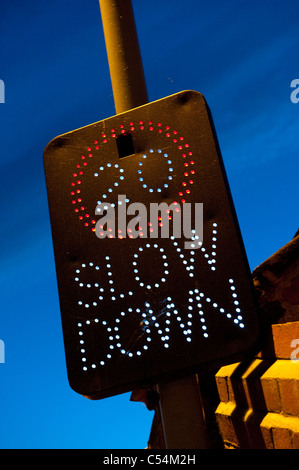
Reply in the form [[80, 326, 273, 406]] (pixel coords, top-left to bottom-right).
[[99, 0, 209, 449]]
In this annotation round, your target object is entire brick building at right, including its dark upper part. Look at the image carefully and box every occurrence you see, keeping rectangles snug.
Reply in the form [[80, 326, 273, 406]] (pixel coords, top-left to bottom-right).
[[215, 235, 299, 449]]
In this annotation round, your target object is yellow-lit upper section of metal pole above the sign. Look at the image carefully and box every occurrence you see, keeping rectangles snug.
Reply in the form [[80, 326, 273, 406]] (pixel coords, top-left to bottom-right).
[[99, 0, 148, 114]]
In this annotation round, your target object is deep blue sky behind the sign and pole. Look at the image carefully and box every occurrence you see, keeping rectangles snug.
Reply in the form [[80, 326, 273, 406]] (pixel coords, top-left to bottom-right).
[[0, 0, 299, 449]]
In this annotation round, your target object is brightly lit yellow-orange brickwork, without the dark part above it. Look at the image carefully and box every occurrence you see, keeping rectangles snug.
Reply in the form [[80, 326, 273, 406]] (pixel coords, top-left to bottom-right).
[[216, 322, 299, 449]]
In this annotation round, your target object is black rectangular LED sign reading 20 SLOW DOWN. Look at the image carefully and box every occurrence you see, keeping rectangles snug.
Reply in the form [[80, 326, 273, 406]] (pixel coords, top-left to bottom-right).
[[44, 91, 259, 398]]
